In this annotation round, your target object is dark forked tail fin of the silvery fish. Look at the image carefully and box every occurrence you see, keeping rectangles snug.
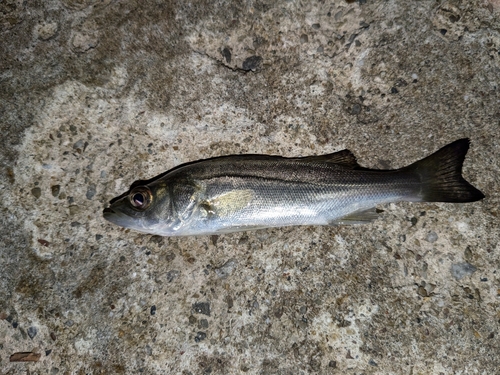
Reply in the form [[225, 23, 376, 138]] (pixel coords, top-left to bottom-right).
[[404, 138, 484, 203]]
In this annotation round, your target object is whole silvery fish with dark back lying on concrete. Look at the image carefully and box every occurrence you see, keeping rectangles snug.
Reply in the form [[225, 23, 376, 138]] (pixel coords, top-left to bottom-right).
[[103, 138, 484, 236]]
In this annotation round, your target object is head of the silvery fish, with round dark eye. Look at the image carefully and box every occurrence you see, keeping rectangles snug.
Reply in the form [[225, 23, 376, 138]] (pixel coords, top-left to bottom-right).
[[103, 184, 175, 235]]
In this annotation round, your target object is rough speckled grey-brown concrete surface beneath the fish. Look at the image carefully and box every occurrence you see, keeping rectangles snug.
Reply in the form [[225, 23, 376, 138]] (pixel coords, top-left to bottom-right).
[[0, 0, 500, 374]]
